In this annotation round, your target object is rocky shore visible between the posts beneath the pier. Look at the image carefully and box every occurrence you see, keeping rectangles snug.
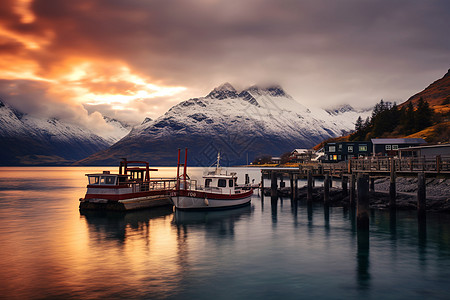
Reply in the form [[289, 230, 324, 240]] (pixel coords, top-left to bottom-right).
[[264, 178, 450, 213]]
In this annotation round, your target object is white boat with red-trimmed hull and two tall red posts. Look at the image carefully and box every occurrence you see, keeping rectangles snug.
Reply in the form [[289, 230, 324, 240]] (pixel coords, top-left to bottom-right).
[[171, 149, 253, 210]]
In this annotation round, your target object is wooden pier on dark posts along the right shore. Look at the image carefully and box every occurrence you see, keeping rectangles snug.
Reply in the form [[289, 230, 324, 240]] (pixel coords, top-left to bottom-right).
[[261, 156, 450, 227]]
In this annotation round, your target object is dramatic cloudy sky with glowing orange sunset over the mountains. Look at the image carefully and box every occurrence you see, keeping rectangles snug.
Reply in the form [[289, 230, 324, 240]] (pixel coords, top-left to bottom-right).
[[0, 0, 450, 134]]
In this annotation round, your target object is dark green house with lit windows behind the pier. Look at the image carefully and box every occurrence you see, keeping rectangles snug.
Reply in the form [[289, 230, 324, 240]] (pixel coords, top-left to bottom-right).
[[323, 141, 372, 162]]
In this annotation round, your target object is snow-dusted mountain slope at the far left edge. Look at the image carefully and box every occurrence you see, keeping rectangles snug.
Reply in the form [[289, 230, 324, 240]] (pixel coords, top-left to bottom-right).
[[0, 101, 110, 165]]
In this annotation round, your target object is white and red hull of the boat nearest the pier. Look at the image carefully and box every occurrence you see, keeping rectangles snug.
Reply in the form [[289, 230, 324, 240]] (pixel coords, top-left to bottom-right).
[[171, 190, 253, 210]]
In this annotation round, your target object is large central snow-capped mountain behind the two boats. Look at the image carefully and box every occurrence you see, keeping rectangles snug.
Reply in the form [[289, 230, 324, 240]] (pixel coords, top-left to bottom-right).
[[80, 83, 372, 165]]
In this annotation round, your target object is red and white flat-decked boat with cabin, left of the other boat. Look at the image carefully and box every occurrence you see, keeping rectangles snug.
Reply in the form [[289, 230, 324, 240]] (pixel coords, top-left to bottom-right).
[[79, 159, 177, 211]]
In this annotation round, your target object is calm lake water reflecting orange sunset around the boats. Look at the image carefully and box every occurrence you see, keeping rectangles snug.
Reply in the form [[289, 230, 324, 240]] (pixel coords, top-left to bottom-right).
[[0, 167, 450, 299]]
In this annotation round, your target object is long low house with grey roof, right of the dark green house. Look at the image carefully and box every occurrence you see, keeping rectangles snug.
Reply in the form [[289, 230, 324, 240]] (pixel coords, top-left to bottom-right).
[[372, 138, 426, 156]]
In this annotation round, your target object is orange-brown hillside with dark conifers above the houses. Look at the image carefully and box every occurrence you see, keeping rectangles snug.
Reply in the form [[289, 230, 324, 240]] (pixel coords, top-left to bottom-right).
[[322, 70, 450, 143]]
